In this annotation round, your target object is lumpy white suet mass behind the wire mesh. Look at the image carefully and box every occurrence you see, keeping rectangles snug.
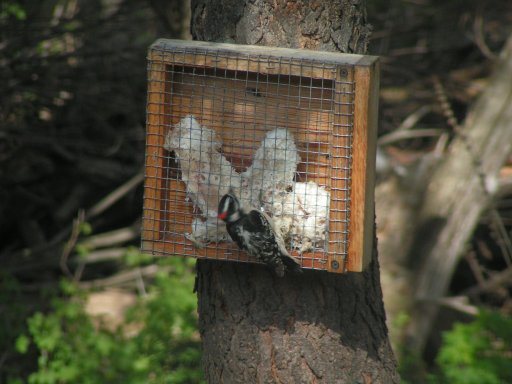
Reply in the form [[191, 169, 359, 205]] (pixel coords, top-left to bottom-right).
[[164, 115, 330, 252]]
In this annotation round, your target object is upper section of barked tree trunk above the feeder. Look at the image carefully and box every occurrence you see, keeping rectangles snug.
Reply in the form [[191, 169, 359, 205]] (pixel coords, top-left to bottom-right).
[[191, 0, 371, 53]]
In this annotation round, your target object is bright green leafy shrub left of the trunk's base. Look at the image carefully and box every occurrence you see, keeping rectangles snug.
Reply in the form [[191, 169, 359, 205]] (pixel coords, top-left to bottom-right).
[[11, 259, 203, 384]]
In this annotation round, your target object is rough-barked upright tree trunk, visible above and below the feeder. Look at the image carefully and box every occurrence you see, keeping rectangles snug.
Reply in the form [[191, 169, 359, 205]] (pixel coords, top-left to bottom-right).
[[191, 0, 399, 384]]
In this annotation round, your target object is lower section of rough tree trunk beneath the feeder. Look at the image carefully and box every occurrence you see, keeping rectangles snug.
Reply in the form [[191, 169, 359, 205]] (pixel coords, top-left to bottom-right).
[[198, 236, 398, 383]]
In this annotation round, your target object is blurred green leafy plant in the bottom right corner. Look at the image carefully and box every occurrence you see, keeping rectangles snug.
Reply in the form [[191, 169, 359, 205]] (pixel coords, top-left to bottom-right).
[[432, 311, 512, 384]]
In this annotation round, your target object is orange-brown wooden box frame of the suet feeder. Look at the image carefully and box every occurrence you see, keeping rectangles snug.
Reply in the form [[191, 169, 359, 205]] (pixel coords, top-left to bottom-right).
[[142, 39, 379, 273]]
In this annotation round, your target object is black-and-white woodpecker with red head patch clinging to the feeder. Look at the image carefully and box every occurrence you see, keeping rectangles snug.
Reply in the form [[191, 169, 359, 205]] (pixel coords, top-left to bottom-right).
[[218, 192, 302, 277]]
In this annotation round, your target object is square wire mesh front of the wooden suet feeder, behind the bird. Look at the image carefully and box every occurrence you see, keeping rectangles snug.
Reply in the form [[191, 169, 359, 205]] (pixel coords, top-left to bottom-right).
[[142, 41, 378, 272]]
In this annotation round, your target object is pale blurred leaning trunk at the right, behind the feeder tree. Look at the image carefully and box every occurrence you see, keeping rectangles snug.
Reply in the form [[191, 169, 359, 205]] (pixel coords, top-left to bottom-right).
[[408, 36, 512, 351]]
